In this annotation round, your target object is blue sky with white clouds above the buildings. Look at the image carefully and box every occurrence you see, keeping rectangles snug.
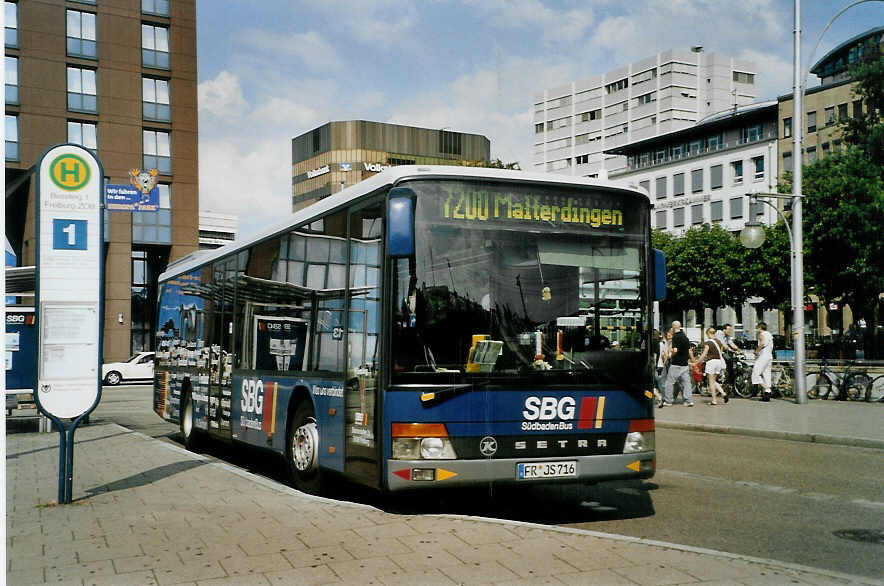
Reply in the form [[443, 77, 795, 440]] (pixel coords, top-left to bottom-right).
[[197, 0, 884, 236]]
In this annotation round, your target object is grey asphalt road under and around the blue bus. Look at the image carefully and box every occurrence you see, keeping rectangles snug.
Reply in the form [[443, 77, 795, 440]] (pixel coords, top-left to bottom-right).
[[22, 386, 884, 578]]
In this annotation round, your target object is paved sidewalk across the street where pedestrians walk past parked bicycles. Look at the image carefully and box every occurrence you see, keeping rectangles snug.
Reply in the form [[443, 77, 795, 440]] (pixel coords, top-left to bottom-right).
[[655, 396, 884, 449]]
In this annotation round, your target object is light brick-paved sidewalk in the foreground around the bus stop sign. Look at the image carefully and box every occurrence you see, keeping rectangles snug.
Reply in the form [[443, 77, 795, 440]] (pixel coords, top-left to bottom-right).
[[6, 422, 880, 586]]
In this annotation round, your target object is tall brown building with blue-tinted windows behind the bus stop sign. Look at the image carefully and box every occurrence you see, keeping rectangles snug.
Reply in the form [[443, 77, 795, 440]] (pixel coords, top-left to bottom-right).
[[4, 0, 199, 361]]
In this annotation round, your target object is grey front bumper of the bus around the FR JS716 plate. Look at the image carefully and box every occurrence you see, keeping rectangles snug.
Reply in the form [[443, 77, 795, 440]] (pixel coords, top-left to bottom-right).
[[387, 452, 656, 491]]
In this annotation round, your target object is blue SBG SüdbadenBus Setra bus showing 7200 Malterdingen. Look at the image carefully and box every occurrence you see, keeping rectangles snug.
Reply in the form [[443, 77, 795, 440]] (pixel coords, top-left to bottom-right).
[[154, 166, 665, 493]]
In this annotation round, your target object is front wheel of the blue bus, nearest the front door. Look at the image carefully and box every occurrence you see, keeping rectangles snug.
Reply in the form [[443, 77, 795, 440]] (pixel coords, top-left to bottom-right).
[[285, 400, 322, 494]]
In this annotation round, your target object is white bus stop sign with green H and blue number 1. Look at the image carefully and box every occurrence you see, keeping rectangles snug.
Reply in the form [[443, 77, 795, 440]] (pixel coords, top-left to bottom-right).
[[34, 144, 104, 504]]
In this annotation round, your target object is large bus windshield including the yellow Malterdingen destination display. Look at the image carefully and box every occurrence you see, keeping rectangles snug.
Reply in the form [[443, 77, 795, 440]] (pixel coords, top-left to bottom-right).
[[392, 181, 649, 384]]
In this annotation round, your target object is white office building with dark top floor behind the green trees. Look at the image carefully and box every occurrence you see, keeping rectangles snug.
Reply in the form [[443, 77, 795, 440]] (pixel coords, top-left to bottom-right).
[[607, 101, 778, 333]]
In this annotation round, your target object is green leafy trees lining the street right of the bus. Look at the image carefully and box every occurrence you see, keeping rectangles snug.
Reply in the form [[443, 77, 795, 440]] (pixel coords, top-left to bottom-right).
[[653, 51, 884, 357]]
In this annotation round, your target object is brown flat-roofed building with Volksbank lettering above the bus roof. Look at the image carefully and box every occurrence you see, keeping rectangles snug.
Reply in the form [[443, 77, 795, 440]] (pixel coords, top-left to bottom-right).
[[292, 120, 491, 211]]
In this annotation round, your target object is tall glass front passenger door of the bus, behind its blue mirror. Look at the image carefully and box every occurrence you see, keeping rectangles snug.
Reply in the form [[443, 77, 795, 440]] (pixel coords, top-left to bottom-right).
[[344, 200, 384, 486]]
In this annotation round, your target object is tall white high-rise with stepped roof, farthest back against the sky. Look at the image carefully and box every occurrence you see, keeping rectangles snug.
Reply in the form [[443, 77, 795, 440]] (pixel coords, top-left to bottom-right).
[[532, 47, 755, 177]]
